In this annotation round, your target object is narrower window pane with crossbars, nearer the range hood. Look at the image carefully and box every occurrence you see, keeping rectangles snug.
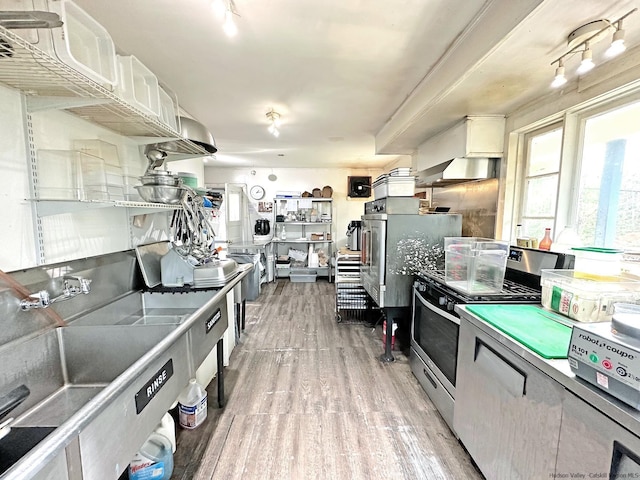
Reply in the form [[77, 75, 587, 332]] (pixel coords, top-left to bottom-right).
[[518, 127, 562, 239]]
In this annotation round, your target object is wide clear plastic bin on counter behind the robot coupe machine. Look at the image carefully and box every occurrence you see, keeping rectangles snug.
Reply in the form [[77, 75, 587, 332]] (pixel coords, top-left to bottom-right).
[[540, 270, 640, 322]]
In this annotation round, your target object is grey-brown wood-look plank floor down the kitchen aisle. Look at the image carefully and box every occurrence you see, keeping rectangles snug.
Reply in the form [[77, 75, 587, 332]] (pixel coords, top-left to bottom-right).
[[171, 279, 482, 480]]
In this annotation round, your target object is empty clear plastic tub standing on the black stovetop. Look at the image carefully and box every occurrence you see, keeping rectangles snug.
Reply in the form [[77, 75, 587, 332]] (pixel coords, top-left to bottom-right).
[[444, 237, 509, 294]]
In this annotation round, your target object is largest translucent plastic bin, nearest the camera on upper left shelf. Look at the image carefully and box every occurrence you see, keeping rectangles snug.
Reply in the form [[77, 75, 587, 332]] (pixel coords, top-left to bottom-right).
[[0, 0, 118, 90]]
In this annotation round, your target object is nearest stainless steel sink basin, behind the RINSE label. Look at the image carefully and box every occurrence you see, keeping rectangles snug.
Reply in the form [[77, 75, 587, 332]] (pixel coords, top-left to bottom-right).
[[6, 325, 179, 427]]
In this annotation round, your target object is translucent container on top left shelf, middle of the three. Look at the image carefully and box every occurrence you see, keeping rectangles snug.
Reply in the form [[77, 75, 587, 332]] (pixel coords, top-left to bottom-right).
[[116, 55, 160, 117]]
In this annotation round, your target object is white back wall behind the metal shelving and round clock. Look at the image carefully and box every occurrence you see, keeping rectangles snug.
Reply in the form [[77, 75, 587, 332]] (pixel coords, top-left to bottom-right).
[[205, 166, 384, 248]]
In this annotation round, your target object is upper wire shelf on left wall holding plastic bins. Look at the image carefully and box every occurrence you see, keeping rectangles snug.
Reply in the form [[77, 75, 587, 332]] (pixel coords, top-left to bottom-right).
[[0, 26, 210, 156]]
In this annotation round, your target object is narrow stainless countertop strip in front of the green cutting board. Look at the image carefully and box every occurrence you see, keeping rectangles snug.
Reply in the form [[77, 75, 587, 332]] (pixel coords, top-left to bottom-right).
[[455, 305, 640, 437]]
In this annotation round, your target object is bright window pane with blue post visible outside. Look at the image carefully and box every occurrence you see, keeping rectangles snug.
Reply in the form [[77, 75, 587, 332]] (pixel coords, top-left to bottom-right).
[[576, 102, 640, 248]]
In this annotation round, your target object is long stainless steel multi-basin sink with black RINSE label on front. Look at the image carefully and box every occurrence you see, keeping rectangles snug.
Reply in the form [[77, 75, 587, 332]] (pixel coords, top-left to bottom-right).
[[0, 259, 249, 480]]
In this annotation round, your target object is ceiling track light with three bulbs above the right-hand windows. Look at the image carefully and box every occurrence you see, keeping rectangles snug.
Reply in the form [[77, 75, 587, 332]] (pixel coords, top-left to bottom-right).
[[551, 8, 638, 88]]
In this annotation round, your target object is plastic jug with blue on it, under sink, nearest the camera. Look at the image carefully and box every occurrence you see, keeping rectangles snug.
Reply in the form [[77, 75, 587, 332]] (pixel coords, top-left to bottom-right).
[[127, 432, 173, 480]]
